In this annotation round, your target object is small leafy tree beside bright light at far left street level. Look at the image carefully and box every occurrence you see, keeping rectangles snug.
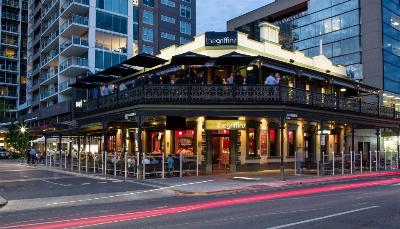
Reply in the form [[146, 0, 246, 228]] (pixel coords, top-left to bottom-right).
[[6, 122, 30, 157]]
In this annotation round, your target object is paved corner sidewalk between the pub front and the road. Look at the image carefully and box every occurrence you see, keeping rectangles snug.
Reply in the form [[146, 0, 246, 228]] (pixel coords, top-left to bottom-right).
[[144, 171, 400, 195]]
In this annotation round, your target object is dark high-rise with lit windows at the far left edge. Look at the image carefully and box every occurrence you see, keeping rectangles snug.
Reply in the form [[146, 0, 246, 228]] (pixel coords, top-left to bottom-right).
[[0, 0, 28, 122]]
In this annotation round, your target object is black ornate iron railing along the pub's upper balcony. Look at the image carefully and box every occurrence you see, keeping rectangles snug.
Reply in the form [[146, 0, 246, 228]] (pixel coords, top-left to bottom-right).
[[76, 85, 400, 119]]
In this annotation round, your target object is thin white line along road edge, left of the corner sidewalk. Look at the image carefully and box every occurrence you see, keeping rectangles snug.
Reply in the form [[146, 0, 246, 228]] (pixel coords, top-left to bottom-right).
[[46, 180, 214, 206]]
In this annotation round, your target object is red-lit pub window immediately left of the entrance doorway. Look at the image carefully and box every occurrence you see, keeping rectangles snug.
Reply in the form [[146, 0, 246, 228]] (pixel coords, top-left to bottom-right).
[[175, 130, 194, 156]]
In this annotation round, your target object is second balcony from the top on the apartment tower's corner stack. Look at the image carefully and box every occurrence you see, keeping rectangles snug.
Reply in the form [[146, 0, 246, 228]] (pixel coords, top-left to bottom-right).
[[60, 15, 89, 37]]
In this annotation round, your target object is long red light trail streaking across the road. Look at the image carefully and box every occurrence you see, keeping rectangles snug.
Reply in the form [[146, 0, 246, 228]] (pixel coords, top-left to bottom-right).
[[4, 178, 400, 229]]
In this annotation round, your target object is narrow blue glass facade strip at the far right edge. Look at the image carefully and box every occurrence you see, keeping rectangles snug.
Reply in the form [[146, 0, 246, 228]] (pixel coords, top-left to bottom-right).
[[382, 0, 400, 94]]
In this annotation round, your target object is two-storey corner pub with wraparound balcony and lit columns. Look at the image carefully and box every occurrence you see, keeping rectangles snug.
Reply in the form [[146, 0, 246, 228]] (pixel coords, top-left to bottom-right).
[[33, 23, 400, 176]]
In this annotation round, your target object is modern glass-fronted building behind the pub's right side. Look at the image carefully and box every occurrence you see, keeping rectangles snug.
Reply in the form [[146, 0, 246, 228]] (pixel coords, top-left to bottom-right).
[[228, 0, 400, 109]]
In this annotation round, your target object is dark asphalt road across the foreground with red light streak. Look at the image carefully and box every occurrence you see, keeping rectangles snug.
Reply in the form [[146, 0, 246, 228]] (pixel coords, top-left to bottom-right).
[[0, 161, 400, 229]]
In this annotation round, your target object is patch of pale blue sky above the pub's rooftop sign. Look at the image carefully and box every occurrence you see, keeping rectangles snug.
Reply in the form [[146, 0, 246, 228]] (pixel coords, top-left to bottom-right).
[[196, 0, 271, 34]]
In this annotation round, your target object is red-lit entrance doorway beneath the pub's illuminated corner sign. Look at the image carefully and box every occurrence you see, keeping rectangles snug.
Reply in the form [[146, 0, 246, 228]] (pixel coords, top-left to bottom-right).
[[212, 131, 231, 173]]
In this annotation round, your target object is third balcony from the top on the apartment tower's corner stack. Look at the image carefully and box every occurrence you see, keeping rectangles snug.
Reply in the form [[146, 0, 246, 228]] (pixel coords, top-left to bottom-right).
[[60, 36, 89, 57]]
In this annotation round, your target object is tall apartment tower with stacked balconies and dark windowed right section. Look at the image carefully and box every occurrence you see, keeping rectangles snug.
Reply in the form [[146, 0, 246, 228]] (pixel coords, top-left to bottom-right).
[[20, 0, 196, 129]]
